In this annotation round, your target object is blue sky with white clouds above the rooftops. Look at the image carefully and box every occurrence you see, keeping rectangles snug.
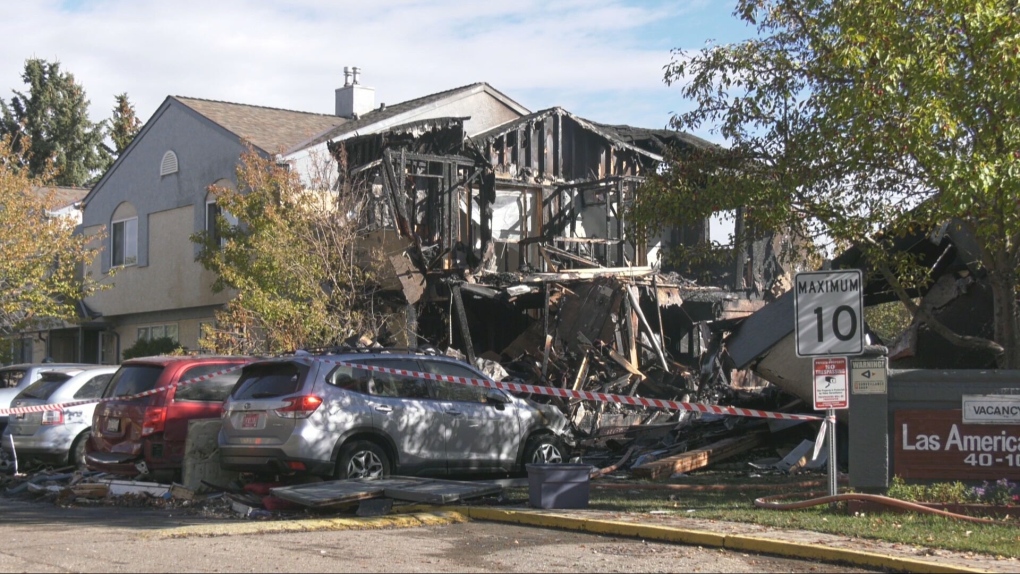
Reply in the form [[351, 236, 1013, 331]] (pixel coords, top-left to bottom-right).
[[0, 0, 754, 141]]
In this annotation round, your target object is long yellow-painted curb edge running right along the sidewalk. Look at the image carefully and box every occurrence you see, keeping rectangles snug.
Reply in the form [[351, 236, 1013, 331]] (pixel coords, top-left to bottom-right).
[[409, 507, 987, 573]]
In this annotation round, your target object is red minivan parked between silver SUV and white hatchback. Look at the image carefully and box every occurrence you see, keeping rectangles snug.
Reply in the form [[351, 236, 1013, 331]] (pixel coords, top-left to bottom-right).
[[85, 355, 251, 480]]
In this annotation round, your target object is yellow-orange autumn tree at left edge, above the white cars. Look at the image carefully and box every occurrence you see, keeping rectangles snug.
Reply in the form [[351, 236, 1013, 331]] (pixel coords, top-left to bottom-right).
[[0, 137, 104, 337]]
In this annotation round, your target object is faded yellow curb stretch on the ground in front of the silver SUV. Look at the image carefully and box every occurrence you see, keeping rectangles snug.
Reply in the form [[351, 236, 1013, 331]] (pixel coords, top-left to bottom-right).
[[141, 511, 468, 538]]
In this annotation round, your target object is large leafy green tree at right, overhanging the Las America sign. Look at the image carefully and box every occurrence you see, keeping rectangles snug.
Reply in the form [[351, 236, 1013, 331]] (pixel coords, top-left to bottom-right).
[[634, 0, 1020, 368]]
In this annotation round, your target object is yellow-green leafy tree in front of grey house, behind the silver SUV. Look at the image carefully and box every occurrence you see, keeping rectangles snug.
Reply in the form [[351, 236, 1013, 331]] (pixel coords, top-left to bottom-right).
[[192, 144, 385, 354]]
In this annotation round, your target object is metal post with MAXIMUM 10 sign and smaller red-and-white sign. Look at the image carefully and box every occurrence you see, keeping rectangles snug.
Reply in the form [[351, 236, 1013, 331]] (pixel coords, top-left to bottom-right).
[[794, 269, 864, 503]]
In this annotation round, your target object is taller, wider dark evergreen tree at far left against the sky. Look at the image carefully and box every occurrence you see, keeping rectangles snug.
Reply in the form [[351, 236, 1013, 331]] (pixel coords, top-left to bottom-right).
[[0, 59, 110, 187]]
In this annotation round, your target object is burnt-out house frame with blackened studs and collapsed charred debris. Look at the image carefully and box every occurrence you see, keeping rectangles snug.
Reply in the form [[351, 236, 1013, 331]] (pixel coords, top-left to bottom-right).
[[329, 108, 816, 477]]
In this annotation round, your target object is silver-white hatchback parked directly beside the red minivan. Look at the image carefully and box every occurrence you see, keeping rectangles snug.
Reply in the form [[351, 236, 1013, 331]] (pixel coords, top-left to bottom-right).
[[0, 366, 117, 468]]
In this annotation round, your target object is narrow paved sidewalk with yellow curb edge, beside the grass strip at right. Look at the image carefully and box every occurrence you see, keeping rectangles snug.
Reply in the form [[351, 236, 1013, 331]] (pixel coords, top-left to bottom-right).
[[434, 506, 1020, 572]]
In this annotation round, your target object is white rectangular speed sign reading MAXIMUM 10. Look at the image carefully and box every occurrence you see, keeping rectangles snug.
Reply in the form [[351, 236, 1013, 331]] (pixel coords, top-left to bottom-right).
[[794, 269, 864, 357]]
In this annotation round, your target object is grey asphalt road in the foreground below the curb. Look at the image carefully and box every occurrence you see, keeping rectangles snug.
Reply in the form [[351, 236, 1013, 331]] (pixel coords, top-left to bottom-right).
[[0, 499, 881, 572]]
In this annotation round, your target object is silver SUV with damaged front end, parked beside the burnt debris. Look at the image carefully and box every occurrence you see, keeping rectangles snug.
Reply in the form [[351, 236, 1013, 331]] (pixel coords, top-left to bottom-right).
[[218, 352, 569, 478]]
